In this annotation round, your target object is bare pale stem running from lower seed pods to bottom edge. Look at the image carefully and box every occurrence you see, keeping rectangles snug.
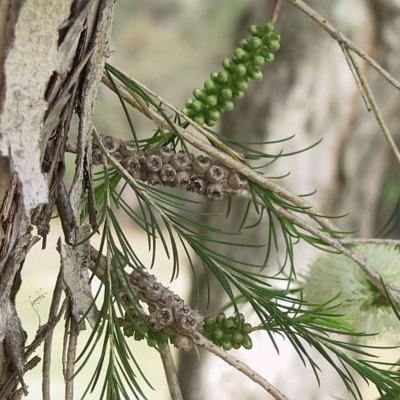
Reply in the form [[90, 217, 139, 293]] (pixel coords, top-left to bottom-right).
[[193, 334, 289, 400]]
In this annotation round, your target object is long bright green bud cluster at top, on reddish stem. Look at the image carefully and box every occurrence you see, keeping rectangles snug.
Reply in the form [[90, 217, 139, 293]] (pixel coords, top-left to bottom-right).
[[182, 22, 280, 126]]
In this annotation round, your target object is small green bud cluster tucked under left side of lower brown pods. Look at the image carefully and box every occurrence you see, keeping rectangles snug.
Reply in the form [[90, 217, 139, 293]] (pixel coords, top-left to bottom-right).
[[122, 310, 170, 348]]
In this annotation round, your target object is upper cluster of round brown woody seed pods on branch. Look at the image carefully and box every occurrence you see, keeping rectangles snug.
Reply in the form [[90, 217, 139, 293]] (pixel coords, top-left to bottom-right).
[[92, 136, 247, 200]]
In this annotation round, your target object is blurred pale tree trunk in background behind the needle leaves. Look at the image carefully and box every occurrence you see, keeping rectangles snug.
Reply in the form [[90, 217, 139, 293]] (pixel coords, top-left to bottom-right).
[[179, 0, 400, 400]]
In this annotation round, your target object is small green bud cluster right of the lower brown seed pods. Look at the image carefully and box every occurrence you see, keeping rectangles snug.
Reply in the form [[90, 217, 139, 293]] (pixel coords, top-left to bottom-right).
[[198, 313, 253, 351]]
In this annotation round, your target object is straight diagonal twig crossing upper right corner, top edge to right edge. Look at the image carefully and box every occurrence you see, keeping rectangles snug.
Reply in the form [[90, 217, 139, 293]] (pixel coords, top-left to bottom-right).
[[287, 0, 400, 90]]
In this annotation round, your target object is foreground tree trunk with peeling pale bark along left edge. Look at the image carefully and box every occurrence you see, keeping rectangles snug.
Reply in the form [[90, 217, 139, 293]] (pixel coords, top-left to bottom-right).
[[0, 0, 114, 399]]
